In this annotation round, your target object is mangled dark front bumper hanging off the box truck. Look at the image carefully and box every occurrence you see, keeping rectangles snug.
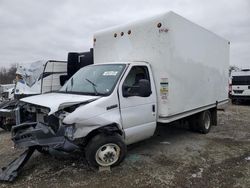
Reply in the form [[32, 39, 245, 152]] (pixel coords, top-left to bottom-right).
[[12, 122, 79, 152]]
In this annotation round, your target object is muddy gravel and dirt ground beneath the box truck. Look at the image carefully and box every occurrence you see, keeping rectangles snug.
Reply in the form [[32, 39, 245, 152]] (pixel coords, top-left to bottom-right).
[[0, 105, 250, 188]]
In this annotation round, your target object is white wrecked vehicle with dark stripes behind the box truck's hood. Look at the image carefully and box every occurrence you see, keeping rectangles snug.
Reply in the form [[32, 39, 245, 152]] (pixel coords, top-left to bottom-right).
[[15, 60, 67, 98]]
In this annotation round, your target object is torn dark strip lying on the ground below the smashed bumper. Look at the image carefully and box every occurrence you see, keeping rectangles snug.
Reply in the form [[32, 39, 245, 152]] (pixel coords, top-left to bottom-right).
[[0, 148, 35, 182]]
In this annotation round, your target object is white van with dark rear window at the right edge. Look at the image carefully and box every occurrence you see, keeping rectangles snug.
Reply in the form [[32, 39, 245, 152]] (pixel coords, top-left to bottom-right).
[[231, 69, 250, 104]]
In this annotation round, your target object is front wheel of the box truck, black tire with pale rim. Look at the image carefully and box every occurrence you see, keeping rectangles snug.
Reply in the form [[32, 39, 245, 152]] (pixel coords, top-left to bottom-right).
[[85, 134, 127, 167]]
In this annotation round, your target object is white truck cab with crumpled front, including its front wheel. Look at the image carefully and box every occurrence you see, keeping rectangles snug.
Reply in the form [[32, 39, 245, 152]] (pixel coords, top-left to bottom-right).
[[12, 62, 157, 166]]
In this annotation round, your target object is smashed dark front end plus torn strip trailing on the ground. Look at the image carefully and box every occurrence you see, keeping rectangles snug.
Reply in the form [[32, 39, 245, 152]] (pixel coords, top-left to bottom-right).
[[0, 102, 85, 182]]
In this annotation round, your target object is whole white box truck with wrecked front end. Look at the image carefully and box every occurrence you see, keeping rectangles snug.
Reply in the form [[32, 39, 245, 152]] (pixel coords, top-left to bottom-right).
[[9, 12, 229, 170]]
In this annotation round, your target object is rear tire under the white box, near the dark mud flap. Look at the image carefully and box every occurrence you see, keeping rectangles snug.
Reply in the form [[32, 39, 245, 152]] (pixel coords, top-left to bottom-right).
[[198, 110, 212, 134]]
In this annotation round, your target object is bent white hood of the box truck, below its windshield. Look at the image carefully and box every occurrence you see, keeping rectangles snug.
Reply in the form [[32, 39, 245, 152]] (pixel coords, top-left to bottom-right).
[[21, 93, 100, 115]]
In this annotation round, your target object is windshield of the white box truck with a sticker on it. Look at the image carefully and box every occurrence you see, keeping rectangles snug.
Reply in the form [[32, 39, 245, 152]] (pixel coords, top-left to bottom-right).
[[59, 64, 125, 95]]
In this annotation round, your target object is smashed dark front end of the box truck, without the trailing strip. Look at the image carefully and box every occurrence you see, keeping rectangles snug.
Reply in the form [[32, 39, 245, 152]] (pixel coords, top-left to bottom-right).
[[12, 103, 79, 152]]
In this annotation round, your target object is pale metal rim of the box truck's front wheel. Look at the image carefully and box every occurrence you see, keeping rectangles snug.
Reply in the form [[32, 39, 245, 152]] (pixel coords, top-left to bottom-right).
[[95, 143, 120, 166]]
